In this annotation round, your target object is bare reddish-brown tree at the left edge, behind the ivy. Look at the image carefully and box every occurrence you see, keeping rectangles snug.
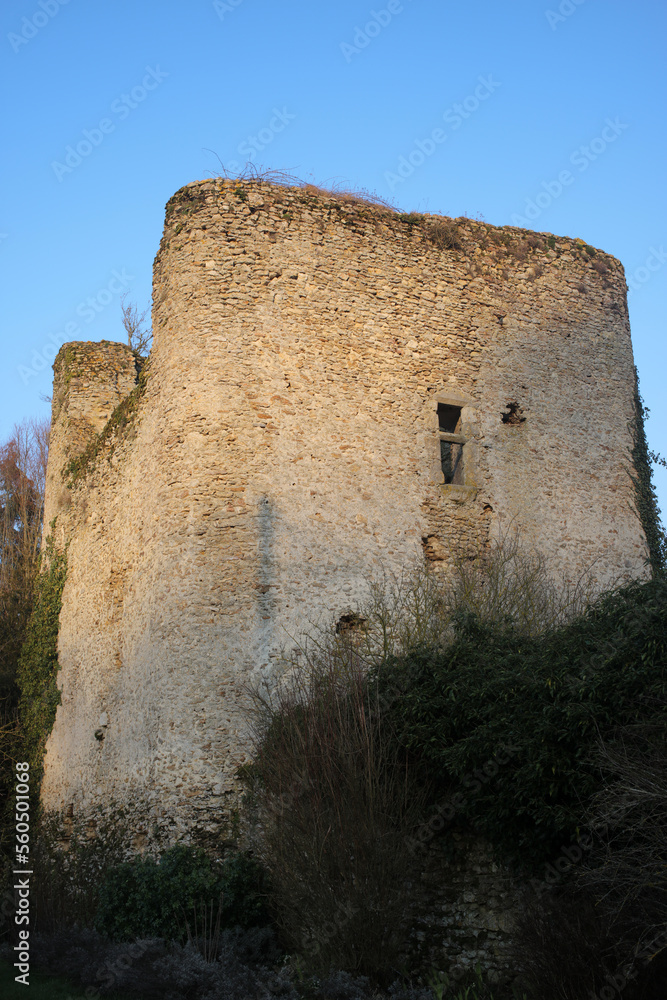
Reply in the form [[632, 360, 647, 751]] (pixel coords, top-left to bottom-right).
[[0, 419, 50, 698]]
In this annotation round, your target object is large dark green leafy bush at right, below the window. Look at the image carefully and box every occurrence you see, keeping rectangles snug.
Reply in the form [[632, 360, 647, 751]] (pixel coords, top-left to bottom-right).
[[373, 577, 667, 867]]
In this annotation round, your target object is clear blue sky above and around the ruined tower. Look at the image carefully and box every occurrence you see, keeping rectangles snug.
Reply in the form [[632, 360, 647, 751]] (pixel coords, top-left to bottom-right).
[[0, 0, 667, 513]]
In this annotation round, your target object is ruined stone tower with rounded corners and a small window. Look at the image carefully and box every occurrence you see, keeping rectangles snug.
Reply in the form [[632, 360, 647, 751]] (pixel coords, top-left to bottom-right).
[[42, 180, 646, 829]]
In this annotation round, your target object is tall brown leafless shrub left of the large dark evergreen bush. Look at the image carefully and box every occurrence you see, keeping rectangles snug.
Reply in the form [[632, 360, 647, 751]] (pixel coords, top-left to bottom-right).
[[245, 635, 434, 976]]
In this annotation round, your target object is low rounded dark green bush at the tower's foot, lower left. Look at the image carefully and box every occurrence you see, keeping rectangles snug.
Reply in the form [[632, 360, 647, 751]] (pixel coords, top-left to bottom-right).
[[97, 845, 268, 941]]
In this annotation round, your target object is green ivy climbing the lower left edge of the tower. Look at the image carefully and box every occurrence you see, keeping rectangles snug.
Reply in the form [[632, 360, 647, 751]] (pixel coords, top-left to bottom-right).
[[17, 537, 67, 798]]
